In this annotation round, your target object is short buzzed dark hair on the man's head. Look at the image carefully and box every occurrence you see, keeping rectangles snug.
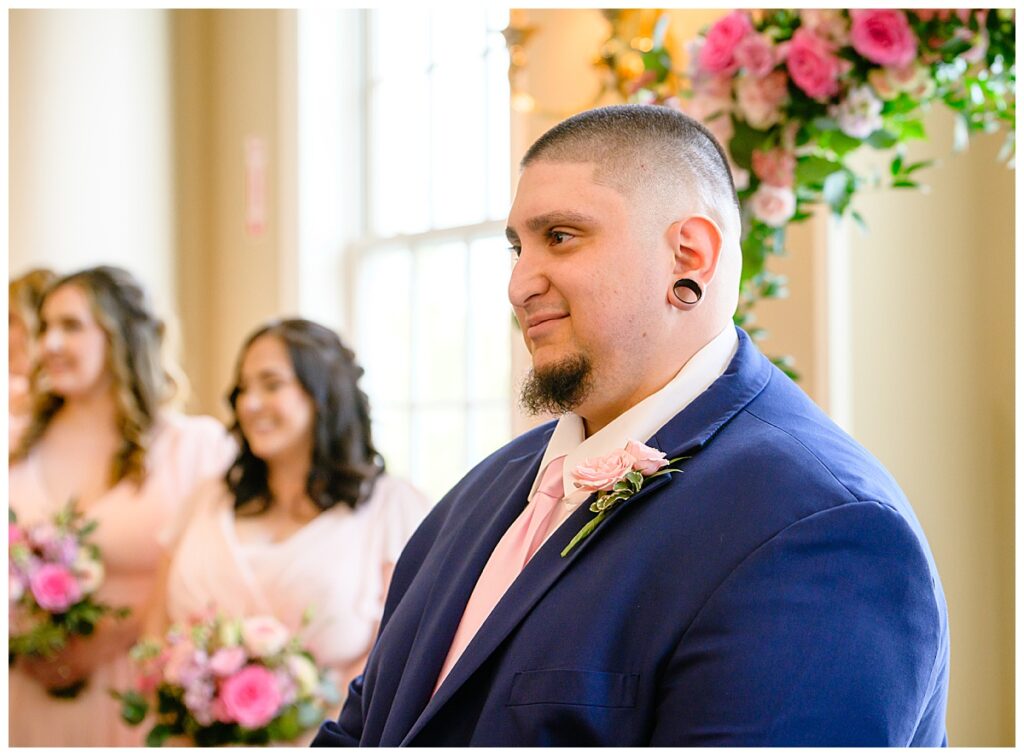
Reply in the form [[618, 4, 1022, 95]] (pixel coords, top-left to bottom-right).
[[519, 104, 740, 241]]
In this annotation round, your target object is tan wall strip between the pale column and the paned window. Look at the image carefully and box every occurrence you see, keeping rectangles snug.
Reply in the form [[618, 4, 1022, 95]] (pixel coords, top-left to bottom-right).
[[173, 10, 296, 418]]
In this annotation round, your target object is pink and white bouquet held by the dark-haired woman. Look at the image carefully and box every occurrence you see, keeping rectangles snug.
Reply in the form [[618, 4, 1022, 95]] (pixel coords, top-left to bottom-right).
[[112, 614, 341, 746]]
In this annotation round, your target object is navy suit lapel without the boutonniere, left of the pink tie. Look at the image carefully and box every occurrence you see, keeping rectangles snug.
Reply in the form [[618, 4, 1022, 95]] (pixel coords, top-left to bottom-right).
[[382, 445, 546, 743]]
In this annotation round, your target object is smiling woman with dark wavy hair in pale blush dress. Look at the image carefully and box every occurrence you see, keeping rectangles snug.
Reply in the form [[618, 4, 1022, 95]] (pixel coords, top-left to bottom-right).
[[151, 320, 430, 737]]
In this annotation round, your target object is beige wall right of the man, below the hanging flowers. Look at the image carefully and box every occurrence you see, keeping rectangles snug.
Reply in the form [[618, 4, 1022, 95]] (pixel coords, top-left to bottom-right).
[[847, 110, 1015, 746]]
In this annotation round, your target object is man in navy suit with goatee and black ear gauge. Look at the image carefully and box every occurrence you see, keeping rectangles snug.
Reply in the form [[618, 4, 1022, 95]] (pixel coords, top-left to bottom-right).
[[313, 106, 949, 746]]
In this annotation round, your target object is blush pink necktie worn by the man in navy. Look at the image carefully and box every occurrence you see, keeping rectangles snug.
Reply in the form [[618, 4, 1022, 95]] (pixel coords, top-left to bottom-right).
[[434, 455, 565, 692]]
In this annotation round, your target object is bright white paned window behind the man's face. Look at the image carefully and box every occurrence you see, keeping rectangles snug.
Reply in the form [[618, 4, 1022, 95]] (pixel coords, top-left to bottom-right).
[[350, 6, 512, 500]]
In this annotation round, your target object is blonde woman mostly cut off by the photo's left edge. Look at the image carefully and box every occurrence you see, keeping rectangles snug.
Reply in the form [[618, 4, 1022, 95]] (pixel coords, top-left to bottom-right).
[[7, 267, 56, 451]]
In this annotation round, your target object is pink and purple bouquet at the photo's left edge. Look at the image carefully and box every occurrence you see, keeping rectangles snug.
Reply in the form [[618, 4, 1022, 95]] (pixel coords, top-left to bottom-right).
[[7, 502, 130, 698]]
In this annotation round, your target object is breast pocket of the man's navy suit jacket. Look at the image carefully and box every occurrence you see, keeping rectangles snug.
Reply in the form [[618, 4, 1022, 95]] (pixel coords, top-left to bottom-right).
[[508, 669, 640, 709]]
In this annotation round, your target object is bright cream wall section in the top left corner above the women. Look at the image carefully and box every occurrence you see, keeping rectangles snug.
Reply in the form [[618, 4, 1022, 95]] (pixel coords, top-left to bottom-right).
[[8, 10, 176, 314]]
